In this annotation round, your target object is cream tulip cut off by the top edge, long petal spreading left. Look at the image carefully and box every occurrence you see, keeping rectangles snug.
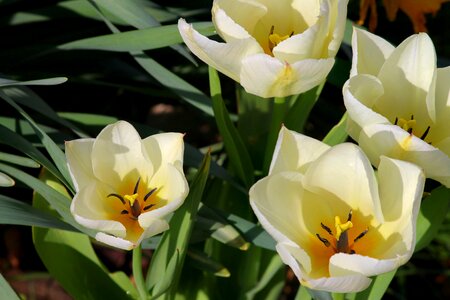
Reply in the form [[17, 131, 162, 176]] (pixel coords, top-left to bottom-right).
[[178, 0, 348, 98]]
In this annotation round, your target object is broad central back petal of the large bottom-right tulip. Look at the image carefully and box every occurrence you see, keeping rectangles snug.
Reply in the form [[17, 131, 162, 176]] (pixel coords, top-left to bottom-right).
[[304, 143, 383, 222]]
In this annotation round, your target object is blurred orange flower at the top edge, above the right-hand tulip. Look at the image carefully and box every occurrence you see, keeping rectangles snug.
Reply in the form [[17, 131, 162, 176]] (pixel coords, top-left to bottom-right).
[[358, 0, 449, 32]]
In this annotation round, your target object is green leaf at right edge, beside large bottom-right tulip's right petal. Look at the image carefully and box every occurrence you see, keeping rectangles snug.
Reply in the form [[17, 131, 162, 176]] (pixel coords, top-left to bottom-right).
[[414, 186, 450, 252]]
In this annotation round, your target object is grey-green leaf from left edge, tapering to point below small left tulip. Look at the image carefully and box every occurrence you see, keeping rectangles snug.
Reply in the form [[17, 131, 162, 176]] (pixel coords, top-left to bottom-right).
[[0, 195, 75, 231]]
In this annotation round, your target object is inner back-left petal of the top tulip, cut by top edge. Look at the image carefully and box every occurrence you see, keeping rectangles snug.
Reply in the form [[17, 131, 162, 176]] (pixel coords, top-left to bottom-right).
[[211, 0, 267, 42]]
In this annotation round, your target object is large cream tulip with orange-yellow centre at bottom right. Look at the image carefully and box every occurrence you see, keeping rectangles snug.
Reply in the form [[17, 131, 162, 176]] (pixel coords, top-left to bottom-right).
[[250, 128, 425, 292]]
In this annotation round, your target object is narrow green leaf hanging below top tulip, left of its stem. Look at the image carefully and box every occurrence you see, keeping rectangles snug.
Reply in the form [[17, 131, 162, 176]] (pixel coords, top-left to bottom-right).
[[209, 67, 255, 188]]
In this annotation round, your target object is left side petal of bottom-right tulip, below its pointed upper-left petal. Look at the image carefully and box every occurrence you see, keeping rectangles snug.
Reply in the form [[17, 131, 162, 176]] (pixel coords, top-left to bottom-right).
[[249, 172, 309, 245]]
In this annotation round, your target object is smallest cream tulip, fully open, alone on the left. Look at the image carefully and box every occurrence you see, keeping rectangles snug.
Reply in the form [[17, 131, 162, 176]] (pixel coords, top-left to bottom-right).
[[66, 121, 188, 250]]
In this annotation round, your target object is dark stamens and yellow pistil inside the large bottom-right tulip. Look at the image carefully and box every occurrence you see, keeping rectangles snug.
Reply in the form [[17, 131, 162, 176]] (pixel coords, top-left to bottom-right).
[[316, 211, 369, 254]]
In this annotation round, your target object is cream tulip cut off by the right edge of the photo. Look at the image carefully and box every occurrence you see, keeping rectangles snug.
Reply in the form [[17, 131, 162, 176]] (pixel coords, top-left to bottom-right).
[[343, 28, 450, 187]]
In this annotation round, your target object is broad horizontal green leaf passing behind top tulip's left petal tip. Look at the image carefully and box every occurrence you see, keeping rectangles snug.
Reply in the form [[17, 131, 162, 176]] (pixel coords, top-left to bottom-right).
[[57, 22, 215, 52]]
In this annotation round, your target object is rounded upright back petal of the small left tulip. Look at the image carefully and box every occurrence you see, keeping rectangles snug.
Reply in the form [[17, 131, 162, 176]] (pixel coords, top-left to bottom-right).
[[92, 121, 153, 187]]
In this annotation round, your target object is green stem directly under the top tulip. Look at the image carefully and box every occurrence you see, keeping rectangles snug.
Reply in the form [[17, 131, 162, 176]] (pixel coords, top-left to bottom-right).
[[263, 97, 286, 174]]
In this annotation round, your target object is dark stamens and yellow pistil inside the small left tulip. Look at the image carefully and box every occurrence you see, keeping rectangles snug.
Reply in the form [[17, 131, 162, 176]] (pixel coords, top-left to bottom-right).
[[107, 178, 157, 220]]
